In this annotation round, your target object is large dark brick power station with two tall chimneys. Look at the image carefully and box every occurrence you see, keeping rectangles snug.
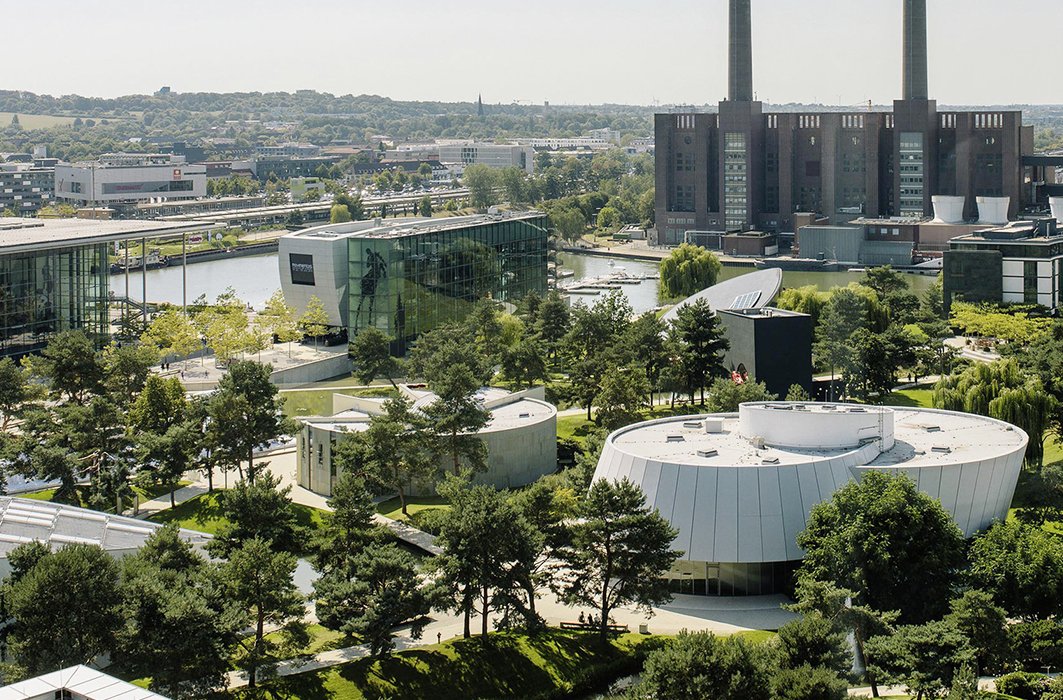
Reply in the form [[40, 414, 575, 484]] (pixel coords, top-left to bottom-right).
[[656, 0, 1033, 245]]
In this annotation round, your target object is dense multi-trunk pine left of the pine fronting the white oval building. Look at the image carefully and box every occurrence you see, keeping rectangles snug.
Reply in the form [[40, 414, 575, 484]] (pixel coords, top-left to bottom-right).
[[436, 484, 534, 638]]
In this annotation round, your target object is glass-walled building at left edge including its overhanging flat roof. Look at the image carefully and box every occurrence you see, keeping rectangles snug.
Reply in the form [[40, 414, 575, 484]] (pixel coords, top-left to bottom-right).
[[0, 218, 209, 357]]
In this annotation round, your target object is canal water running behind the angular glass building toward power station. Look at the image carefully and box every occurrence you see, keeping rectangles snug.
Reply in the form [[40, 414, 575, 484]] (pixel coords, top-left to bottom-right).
[[118, 253, 934, 312]]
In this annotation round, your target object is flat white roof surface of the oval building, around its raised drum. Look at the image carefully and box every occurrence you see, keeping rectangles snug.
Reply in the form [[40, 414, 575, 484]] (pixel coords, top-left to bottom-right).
[[611, 405, 1025, 468]]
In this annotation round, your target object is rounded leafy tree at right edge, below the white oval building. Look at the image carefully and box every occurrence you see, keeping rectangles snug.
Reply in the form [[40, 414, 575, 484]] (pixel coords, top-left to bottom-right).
[[969, 522, 1063, 619]]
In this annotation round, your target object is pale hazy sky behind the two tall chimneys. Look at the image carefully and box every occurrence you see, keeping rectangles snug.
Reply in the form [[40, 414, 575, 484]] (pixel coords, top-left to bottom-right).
[[6, 0, 1063, 105]]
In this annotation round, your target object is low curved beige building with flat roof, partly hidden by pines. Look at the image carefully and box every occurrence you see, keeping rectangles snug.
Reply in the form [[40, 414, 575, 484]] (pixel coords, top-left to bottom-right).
[[297, 386, 557, 496]]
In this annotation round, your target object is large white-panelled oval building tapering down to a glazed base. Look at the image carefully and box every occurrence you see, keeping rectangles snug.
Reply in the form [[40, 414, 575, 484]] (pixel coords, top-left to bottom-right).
[[594, 403, 1028, 595]]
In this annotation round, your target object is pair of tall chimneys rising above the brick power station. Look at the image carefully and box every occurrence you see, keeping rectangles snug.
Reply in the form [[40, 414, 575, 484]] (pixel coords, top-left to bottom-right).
[[727, 0, 930, 102]]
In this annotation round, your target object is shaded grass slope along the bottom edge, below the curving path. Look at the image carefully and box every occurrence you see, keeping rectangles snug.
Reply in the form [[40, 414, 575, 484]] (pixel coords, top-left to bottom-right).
[[236, 630, 667, 700]]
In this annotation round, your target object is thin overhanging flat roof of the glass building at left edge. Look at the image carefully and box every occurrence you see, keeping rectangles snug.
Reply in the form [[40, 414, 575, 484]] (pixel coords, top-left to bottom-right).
[[0, 217, 214, 255]]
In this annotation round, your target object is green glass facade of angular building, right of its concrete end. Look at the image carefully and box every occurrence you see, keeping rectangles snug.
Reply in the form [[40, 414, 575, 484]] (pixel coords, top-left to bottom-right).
[[348, 216, 547, 352]]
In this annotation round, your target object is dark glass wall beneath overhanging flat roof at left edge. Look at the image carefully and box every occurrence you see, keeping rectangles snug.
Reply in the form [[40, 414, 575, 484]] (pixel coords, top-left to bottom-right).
[[0, 244, 111, 357]]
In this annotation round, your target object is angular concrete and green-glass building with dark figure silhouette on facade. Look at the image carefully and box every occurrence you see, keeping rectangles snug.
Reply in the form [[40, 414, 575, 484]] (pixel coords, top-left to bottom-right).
[[279, 212, 549, 353]]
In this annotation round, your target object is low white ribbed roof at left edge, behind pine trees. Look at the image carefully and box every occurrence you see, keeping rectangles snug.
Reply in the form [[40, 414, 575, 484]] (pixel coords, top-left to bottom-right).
[[0, 496, 210, 558]]
